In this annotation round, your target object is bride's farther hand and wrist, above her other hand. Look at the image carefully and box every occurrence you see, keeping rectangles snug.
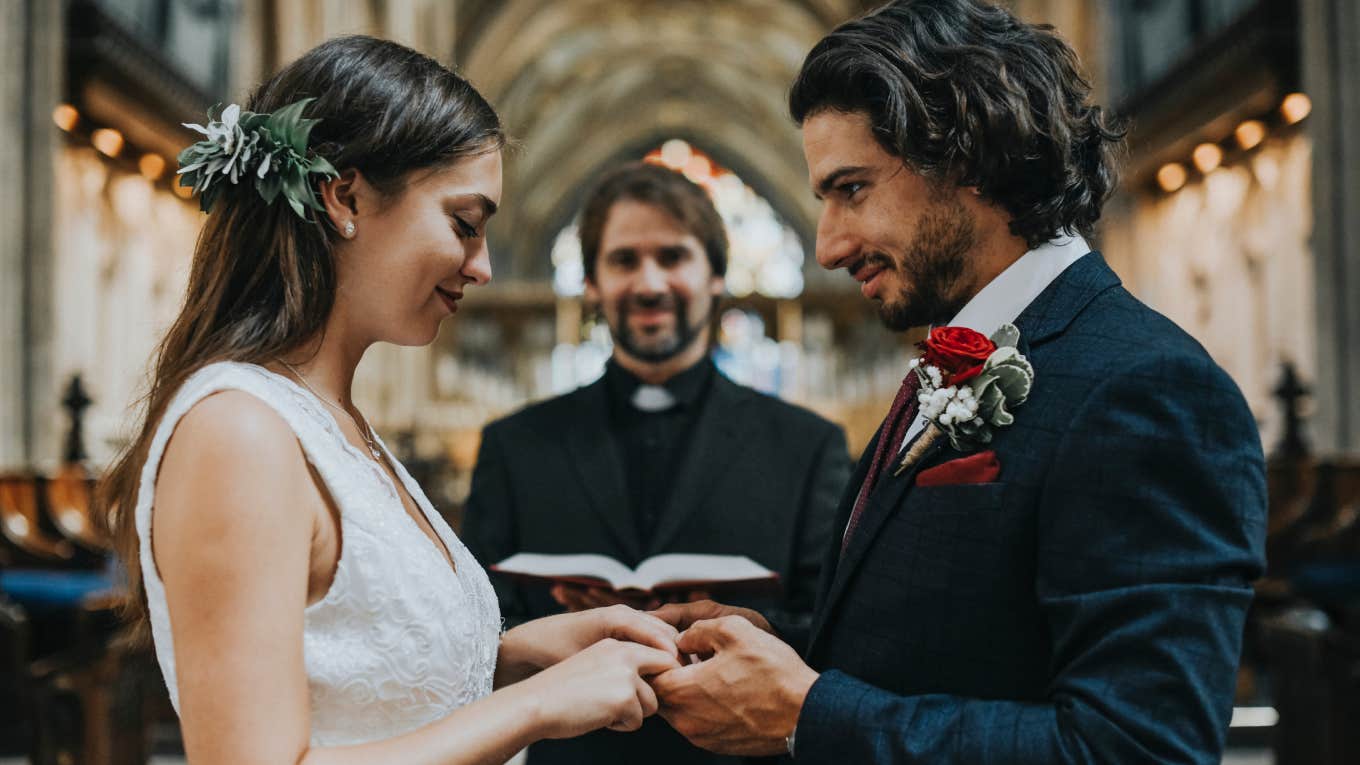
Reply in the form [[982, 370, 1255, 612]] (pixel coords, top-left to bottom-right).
[[496, 606, 680, 686]]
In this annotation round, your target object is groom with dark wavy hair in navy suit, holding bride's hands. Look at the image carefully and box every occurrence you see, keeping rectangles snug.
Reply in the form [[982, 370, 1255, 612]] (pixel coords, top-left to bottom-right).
[[653, 0, 1266, 765]]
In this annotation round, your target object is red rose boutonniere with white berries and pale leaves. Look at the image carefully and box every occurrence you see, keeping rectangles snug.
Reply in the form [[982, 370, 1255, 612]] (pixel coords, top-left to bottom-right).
[[898, 324, 1034, 472]]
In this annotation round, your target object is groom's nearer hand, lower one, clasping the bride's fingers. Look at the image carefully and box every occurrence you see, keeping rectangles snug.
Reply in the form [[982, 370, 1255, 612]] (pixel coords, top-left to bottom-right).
[[651, 615, 817, 757]]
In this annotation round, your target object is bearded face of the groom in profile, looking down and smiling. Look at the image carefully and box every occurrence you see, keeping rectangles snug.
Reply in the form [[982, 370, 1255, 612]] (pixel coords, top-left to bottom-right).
[[802, 109, 979, 331]]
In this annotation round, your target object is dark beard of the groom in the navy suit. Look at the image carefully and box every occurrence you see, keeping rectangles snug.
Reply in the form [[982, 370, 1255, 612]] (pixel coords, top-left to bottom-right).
[[865, 199, 978, 332]]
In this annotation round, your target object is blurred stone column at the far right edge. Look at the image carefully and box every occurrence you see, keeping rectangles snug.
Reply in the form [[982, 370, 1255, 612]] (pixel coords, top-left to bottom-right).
[[1300, 0, 1360, 455]]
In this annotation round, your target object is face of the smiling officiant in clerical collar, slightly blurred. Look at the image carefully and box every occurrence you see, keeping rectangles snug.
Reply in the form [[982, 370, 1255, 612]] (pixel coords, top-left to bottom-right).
[[586, 199, 724, 363]]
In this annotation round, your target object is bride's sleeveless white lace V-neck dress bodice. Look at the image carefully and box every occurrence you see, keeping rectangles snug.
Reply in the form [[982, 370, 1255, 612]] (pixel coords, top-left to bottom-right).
[[136, 362, 500, 746]]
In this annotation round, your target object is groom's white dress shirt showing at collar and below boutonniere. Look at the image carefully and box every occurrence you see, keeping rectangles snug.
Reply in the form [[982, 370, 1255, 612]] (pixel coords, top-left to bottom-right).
[[902, 228, 1091, 448]]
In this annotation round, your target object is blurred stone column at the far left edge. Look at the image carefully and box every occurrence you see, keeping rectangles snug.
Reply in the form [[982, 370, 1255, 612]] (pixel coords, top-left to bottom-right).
[[0, 0, 64, 468]]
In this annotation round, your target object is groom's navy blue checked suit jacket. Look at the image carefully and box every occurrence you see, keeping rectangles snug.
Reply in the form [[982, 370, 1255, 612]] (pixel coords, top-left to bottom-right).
[[796, 253, 1266, 765]]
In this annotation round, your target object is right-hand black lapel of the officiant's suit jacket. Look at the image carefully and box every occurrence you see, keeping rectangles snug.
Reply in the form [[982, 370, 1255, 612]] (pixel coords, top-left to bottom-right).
[[645, 370, 751, 555]]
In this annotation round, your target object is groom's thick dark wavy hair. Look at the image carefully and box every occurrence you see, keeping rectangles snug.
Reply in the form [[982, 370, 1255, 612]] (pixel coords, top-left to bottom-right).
[[789, 0, 1126, 248]]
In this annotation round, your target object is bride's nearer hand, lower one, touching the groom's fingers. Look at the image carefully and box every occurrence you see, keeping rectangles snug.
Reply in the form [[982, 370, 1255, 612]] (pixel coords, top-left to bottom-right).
[[510, 638, 680, 738]]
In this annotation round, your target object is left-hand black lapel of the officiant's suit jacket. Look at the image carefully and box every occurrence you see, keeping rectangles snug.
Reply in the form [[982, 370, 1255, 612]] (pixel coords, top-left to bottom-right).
[[563, 380, 642, 562]]
